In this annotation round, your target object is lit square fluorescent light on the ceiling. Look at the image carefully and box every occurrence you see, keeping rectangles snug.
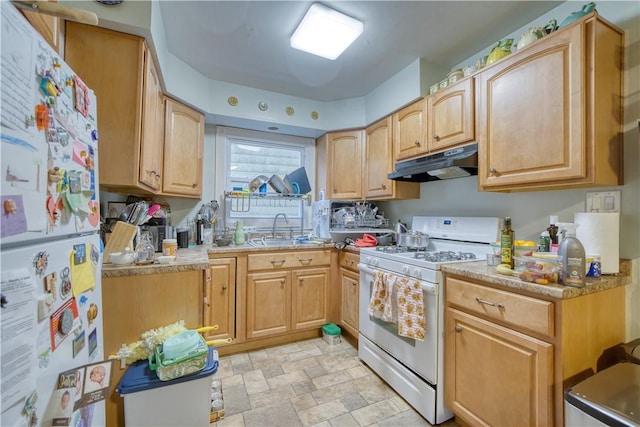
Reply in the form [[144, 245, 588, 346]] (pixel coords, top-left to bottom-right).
[[291, 3, 364, 60]]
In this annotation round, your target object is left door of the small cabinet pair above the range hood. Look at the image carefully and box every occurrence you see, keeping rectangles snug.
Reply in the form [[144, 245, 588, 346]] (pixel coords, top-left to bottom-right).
[[393, 99, 428, 161]]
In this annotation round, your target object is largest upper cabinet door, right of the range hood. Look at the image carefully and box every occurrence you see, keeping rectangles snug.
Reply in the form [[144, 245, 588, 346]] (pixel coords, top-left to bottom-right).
[[476, 25, 587, 189]]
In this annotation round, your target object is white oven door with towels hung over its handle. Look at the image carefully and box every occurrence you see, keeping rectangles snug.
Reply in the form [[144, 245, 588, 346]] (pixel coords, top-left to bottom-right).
[[358, 264, 439, 385]]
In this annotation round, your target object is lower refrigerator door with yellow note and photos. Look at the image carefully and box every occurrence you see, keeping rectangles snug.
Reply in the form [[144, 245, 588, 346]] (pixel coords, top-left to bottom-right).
[[0, 234, 105, 426]]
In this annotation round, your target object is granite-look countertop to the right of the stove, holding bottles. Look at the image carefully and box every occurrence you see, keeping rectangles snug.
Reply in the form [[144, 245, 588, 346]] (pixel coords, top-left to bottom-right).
[[440, 260, 631, 299]]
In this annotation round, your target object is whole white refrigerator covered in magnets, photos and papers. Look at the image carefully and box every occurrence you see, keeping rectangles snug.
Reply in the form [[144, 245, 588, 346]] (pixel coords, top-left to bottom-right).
[[0, 2, 105, 426]]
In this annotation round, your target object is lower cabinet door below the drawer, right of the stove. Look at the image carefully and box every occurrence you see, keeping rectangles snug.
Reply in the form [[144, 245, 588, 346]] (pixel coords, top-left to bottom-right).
[[445, 308, 553, 426]]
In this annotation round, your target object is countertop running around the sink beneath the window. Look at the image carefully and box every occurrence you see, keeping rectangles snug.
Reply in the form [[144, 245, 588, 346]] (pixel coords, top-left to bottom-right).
[[102, 243, 350, 277]]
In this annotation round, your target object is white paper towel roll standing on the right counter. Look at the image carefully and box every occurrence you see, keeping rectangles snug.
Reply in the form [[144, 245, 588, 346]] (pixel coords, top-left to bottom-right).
[[574, 212, 620, 274]]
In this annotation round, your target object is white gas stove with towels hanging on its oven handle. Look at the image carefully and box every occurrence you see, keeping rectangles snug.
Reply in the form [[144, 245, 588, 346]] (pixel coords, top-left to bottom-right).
[[358, 216, 501, 424]]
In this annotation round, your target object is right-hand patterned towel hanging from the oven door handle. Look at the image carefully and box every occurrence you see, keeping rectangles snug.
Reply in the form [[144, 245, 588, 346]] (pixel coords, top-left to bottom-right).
[[396, 277, 426, 341]]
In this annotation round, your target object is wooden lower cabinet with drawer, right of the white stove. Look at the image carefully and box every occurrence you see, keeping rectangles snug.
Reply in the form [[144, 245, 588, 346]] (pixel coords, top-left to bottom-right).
[[444, 275, 626, 427]]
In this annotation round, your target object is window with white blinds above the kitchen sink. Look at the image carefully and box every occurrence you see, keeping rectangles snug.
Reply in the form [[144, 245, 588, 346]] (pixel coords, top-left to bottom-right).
[[216, 128, 315, 232]]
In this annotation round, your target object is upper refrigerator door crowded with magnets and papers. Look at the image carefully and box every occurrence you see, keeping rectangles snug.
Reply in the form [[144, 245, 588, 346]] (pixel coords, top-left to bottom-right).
[[0, 2, 100, 247]]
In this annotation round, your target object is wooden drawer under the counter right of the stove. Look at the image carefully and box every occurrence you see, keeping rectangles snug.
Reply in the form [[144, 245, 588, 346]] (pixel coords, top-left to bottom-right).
[[445, 277, 554, 337]]
